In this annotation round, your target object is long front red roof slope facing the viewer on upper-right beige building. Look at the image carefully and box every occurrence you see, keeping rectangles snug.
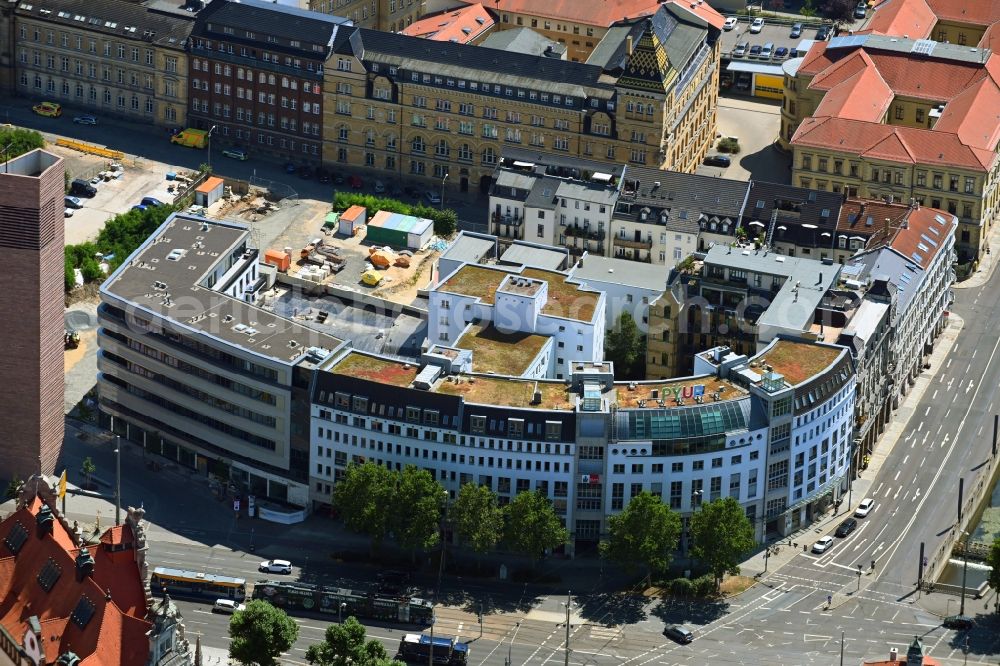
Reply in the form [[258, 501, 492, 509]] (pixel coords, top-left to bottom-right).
[[792, 116, 997, 171]]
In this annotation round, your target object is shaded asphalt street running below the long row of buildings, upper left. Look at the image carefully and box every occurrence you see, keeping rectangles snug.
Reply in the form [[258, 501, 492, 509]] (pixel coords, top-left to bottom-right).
[[0, 98, 489, 224]]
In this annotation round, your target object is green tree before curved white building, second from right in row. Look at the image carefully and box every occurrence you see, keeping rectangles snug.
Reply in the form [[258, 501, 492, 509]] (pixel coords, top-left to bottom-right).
[[600, 491, 681, 576]]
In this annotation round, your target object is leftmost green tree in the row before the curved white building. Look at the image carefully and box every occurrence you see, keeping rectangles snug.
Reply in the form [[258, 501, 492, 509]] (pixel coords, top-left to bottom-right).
[[333, 461, 397, 549]]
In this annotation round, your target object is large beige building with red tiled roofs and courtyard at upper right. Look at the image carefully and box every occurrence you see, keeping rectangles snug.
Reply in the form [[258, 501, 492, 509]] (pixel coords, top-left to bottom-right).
[[779, 31, 1000, 262]]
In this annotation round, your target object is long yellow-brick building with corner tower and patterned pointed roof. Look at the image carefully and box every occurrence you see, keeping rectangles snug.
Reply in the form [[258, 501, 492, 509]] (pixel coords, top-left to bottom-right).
[[323, 3, 721, 192]]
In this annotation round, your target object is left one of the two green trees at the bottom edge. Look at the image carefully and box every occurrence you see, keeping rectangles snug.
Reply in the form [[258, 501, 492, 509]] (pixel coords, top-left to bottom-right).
[[229, 599, 299, 666]]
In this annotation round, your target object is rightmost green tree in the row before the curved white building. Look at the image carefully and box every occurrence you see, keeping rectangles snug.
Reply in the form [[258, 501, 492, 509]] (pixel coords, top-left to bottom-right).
[[691, 497, 754, 588]]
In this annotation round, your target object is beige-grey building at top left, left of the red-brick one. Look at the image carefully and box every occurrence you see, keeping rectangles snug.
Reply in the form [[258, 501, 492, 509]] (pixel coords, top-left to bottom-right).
[[14, 0, 193, 127]]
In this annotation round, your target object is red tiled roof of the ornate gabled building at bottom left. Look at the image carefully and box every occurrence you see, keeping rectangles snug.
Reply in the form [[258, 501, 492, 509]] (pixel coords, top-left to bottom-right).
[[0, 498, 152, 666]]
